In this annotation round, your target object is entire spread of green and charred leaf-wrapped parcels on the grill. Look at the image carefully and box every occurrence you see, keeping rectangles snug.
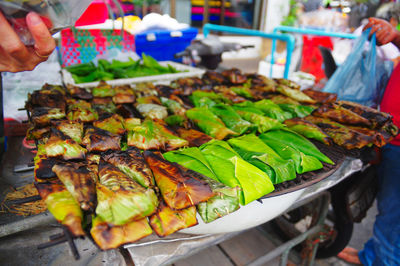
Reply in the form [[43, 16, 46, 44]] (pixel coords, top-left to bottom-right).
[[26, 69, 397, 249]]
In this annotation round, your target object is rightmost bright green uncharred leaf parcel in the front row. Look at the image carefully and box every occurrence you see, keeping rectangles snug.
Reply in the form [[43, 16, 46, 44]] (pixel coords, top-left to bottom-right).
[[260, 129, 334, 164]]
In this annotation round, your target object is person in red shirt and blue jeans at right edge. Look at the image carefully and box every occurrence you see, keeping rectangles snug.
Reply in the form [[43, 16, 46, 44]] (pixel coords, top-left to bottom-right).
[[338, 18, 400, 265]]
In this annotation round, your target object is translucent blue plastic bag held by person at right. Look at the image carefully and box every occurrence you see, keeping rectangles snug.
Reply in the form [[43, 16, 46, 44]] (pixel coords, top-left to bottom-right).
[[323, 30, 393, 106]]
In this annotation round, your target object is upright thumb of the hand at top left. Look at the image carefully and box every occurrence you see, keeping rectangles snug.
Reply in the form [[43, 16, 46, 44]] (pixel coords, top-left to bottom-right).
[[26, 12, 56, 60]]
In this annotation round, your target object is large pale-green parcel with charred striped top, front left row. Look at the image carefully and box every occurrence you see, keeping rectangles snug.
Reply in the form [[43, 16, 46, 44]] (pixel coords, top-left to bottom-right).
[[96, 161, 158, 225]]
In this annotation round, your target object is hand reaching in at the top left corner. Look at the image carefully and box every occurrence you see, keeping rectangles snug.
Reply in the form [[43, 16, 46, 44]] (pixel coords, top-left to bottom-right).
[[0, 12, 56, 72]]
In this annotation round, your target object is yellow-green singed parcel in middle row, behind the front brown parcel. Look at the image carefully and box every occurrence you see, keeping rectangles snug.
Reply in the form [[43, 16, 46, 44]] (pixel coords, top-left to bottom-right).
[[128, 119, 189, 151]]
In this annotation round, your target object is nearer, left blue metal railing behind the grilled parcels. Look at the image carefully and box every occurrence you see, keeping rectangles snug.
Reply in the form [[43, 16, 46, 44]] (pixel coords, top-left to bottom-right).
[[203, 24, 294, 78]]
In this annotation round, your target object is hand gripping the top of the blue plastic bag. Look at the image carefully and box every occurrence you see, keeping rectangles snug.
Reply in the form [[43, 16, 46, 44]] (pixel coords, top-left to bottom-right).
[[363, 18, 400, 49]]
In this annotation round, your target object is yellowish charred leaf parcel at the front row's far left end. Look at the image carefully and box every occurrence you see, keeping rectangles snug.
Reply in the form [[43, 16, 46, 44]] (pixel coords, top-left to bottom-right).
[[35, 183, 85, 237]]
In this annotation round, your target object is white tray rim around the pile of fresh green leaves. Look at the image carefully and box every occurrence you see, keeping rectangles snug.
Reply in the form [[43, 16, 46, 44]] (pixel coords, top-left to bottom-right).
[[61, 61, 205, 88]]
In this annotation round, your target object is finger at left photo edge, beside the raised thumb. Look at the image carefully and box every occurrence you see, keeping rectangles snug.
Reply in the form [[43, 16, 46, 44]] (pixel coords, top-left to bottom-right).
[[0, 12, 29, 63]]
